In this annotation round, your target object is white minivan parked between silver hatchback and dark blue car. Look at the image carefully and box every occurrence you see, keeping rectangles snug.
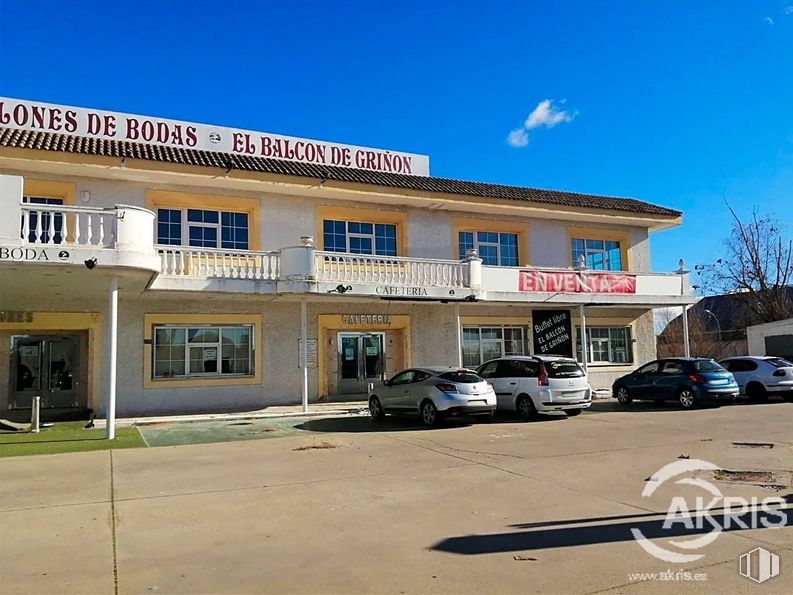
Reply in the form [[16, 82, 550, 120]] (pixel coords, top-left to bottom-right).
[[476, 355, 592, 419]]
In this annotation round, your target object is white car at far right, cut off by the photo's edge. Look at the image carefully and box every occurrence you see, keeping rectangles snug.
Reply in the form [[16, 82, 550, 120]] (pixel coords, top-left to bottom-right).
[[719, 355, 793, 401]]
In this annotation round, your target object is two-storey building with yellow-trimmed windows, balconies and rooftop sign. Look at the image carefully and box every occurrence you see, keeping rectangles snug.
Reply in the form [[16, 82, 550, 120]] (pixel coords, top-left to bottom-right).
[[0, 100, 694, 417]]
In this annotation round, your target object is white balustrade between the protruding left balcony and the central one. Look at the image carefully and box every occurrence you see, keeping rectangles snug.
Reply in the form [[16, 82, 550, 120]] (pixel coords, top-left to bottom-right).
[[156, 246, 279, 280]]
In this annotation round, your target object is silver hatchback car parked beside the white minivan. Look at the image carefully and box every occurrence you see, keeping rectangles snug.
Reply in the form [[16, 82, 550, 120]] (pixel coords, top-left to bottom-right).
[[369, 367, 496, 426]]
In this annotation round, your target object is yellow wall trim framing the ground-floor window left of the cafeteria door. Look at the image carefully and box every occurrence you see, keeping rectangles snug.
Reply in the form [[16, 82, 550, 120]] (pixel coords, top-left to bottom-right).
[[143, 314, 264, 389]]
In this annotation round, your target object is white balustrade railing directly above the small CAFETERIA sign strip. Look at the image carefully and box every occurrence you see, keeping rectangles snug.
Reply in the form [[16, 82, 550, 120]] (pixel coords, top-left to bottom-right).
[[315, 251, 468, 287]]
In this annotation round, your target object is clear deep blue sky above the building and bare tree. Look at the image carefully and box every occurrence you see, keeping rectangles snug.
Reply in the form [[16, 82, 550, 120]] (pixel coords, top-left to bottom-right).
[[0, 0, 793, 271]]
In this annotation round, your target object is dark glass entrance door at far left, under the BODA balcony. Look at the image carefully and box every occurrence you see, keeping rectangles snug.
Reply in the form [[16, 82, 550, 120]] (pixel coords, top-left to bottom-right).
[[8, 335, 86, 409]]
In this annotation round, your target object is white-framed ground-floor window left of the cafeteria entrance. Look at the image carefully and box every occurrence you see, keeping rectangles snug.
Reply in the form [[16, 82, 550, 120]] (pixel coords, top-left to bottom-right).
[[153, 325, 253, 378]]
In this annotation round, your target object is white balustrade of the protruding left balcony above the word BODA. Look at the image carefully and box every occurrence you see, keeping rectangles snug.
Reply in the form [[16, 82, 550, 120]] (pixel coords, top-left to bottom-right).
[[21, 203, 118, 248]]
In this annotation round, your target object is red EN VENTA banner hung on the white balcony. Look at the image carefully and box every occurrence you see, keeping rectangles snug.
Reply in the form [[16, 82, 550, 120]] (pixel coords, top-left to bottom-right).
[[518, 271, 636, 294]]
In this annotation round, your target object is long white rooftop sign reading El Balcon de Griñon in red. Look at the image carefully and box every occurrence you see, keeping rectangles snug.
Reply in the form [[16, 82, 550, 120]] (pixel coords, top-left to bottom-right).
[[0, 97, 430, 176]]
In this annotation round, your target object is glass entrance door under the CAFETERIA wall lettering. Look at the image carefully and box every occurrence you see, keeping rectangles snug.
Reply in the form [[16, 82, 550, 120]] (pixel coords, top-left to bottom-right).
[[338, 333, 385, 393]]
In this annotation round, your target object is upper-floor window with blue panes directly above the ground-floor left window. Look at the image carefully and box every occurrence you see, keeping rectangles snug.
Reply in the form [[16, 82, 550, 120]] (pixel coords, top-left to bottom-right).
[[157, 208, 248, 250]]
